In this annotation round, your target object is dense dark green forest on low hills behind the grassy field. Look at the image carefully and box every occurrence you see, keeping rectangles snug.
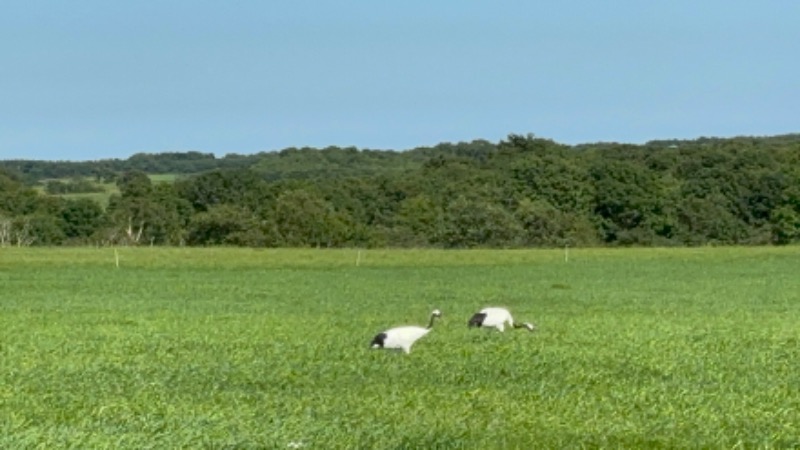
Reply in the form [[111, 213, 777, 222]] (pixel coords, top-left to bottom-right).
[[0, 134, 800, 248]]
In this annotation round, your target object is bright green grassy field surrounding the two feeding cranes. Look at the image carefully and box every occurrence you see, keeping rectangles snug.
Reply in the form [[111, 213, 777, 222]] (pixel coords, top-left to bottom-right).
[[0, 248, 800, 449]]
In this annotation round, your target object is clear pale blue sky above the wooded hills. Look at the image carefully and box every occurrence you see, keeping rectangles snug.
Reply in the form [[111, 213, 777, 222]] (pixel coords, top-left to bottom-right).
[[0, 0, 800, 160]]
